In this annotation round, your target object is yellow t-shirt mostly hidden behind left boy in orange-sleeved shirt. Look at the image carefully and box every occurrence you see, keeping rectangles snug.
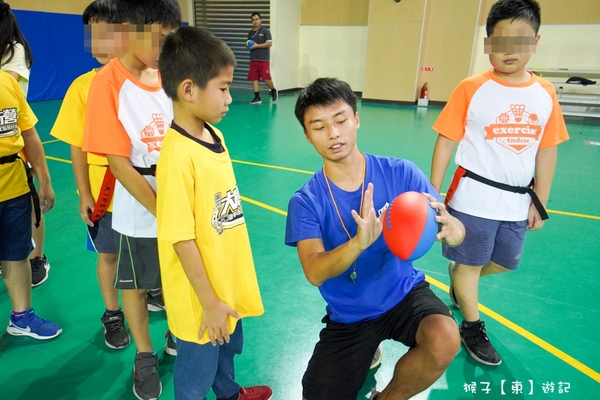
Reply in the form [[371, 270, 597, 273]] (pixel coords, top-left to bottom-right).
[[50, 70, 112, 212]]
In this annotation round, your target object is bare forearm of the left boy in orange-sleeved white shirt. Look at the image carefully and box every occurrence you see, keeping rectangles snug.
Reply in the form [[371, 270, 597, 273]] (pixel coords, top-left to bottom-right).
[[106, 155, 156, 217]]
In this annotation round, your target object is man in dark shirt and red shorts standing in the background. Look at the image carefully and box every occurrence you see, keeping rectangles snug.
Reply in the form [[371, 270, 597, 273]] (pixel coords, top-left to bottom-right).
[[248, 12, 279, 104]]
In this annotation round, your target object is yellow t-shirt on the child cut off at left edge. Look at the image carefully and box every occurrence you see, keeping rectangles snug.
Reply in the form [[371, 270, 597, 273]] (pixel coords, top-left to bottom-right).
[[0, 71, 37, 201]]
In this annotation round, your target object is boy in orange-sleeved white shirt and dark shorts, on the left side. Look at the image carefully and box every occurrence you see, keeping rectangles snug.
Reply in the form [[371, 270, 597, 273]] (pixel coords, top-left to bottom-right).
[[83, 0, 181, 399]]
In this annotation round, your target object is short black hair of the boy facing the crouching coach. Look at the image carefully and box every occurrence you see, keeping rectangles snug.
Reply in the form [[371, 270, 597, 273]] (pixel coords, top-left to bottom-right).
[[158, 26, 236, 100]]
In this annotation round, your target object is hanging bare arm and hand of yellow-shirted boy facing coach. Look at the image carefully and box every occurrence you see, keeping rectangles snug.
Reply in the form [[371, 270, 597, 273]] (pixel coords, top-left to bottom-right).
[[173, 240, 240, 346]]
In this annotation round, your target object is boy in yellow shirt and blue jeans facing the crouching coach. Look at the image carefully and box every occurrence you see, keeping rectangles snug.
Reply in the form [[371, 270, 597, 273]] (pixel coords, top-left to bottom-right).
[[156, 27, 272, 400]]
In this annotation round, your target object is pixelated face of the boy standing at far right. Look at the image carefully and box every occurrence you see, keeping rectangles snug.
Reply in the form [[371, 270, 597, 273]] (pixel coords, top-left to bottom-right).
[[484, 19, 540, 76]]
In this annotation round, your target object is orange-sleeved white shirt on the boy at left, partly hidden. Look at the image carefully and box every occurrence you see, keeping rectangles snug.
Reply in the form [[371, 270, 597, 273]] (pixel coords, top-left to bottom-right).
[[83, 58, 173, 238]]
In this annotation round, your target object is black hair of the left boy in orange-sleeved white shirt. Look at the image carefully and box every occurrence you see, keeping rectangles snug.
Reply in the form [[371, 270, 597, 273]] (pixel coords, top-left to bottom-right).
[[114, 0, 181, 29]]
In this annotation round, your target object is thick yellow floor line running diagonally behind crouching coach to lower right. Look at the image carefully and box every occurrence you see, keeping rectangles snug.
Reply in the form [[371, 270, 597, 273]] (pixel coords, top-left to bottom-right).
[[242, 196, 600, 382]]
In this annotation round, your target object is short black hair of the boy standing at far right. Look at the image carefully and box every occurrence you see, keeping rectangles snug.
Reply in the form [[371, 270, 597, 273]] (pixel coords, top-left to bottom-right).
[[485, 0, 542, 37]]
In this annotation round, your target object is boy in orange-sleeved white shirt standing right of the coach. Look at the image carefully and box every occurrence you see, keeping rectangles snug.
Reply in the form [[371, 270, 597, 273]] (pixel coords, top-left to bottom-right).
[[431, 0, 569, 365]]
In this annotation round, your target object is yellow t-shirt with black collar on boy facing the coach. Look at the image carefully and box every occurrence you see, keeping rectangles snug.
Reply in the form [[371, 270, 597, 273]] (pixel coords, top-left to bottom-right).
[[156, 126, 264, 344]]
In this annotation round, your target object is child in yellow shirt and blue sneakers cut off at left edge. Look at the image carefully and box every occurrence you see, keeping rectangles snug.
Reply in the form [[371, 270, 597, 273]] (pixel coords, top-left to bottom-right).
[[0, 71, 62, 340]]
